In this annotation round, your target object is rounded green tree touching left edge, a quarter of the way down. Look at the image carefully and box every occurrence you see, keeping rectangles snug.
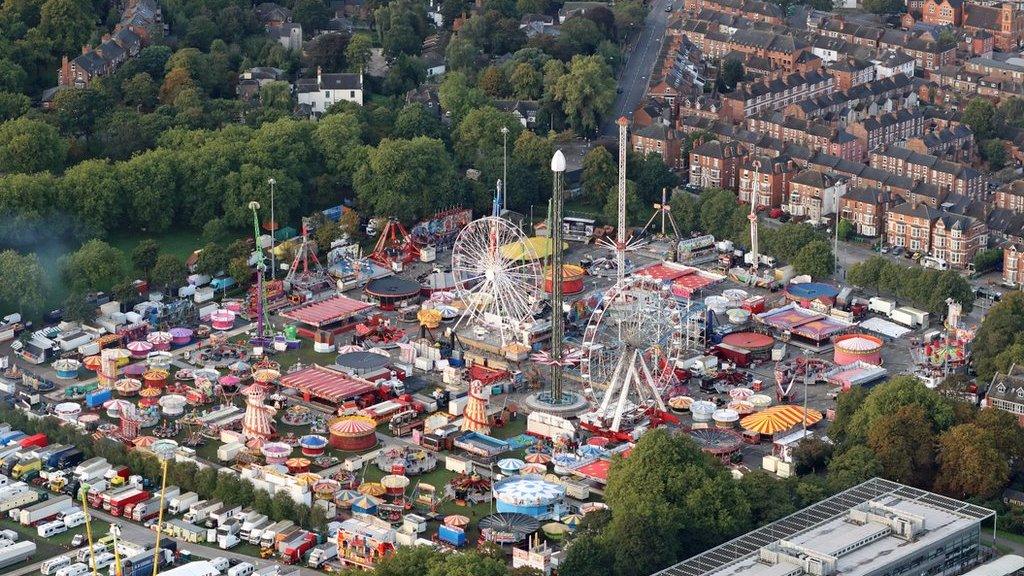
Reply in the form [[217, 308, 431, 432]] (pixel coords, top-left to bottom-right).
[[0, 118, 68, 173]]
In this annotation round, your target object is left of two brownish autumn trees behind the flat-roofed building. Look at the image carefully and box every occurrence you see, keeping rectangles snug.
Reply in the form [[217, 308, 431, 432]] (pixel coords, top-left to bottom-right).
[[865, 403, 935, 488]]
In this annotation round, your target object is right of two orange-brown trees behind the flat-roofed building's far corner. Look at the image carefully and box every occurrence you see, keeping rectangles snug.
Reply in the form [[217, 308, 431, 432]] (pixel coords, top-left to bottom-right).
[[935, 424, 1010, 499]]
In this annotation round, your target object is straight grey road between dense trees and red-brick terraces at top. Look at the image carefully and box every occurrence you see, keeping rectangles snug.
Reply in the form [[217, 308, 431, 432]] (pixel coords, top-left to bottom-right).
[[601, 0, 678, 137]]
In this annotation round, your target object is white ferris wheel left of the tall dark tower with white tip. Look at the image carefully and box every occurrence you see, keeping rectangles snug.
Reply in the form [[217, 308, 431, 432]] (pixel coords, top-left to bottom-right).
[[452, 216, 543, 345]]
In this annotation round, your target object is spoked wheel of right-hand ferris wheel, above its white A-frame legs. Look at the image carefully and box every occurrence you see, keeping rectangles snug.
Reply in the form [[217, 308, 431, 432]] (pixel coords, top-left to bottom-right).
[[580, 276, 686, 390]]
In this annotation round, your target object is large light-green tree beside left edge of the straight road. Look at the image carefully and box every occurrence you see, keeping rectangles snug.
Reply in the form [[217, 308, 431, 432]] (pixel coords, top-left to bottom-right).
[[553, 55, 615, 132]]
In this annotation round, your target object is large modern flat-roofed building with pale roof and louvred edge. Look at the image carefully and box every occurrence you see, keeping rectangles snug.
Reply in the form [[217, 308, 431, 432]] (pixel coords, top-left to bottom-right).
[[655, 478, 995, 576]]
